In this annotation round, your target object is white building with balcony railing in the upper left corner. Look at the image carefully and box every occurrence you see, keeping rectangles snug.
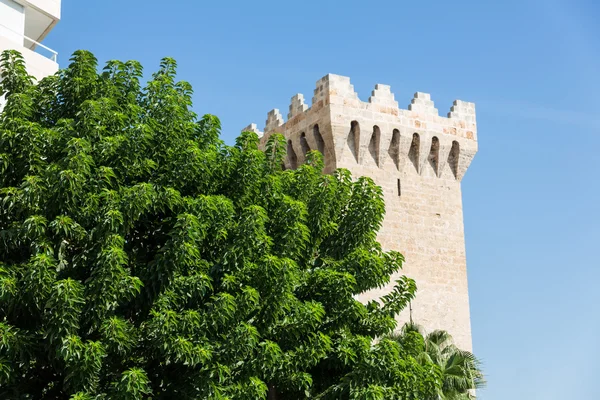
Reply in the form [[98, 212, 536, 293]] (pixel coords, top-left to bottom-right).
[[0, 0, 61, 79]]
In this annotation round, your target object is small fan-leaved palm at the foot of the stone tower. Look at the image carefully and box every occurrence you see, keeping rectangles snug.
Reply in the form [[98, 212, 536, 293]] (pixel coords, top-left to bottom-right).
[[389, 323, 485, 400]]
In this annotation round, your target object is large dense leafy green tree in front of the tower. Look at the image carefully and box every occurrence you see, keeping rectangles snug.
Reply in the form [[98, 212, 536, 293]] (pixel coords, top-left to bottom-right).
[[0, 51, 441, 400]]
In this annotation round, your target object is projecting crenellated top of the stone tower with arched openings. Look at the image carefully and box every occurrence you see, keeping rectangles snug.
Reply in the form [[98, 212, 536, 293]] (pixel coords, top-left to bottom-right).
[[244, 74, 477, 180]]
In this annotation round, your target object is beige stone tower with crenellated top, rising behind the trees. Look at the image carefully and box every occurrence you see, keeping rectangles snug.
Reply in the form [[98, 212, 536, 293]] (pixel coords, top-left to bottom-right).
[[244, 74, 477, 350]]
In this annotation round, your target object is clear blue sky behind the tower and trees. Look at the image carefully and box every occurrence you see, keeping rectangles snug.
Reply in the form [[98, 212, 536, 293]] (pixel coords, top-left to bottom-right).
[[45, 0, 600, 400]]
